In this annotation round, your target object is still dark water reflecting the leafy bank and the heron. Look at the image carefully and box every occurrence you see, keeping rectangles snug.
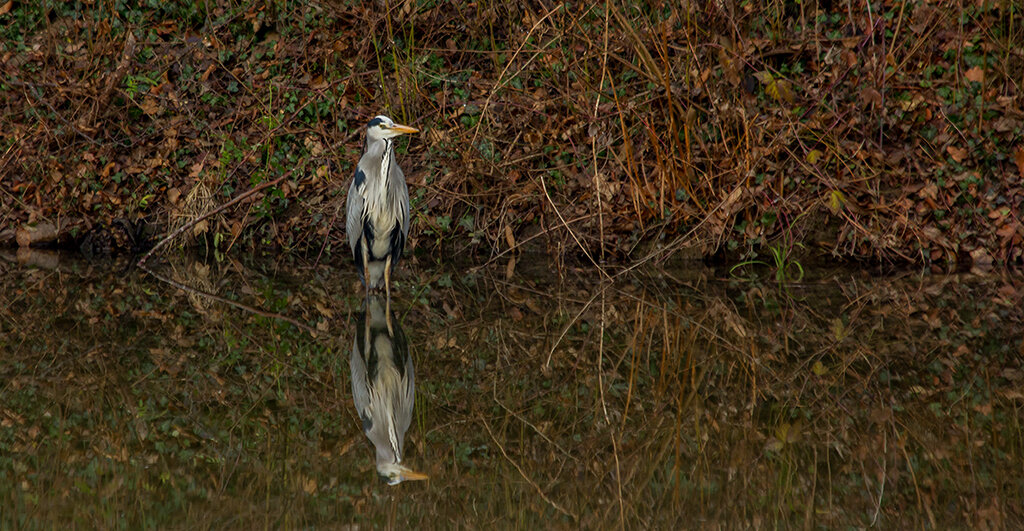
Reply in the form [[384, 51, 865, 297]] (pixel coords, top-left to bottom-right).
[[0, 254, 1024, 529]]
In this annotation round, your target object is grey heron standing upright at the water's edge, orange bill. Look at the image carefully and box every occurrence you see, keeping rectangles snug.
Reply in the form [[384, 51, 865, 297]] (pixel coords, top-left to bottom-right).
[[345, 116, 419, 307]]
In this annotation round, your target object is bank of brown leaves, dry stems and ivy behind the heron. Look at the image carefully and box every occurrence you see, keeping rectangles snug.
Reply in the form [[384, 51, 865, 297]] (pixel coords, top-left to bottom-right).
[[0, 0, 1024, 265]]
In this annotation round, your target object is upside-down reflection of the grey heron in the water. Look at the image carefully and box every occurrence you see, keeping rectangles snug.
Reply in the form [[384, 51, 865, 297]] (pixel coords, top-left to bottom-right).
[[349, 296, 427, 485]]
